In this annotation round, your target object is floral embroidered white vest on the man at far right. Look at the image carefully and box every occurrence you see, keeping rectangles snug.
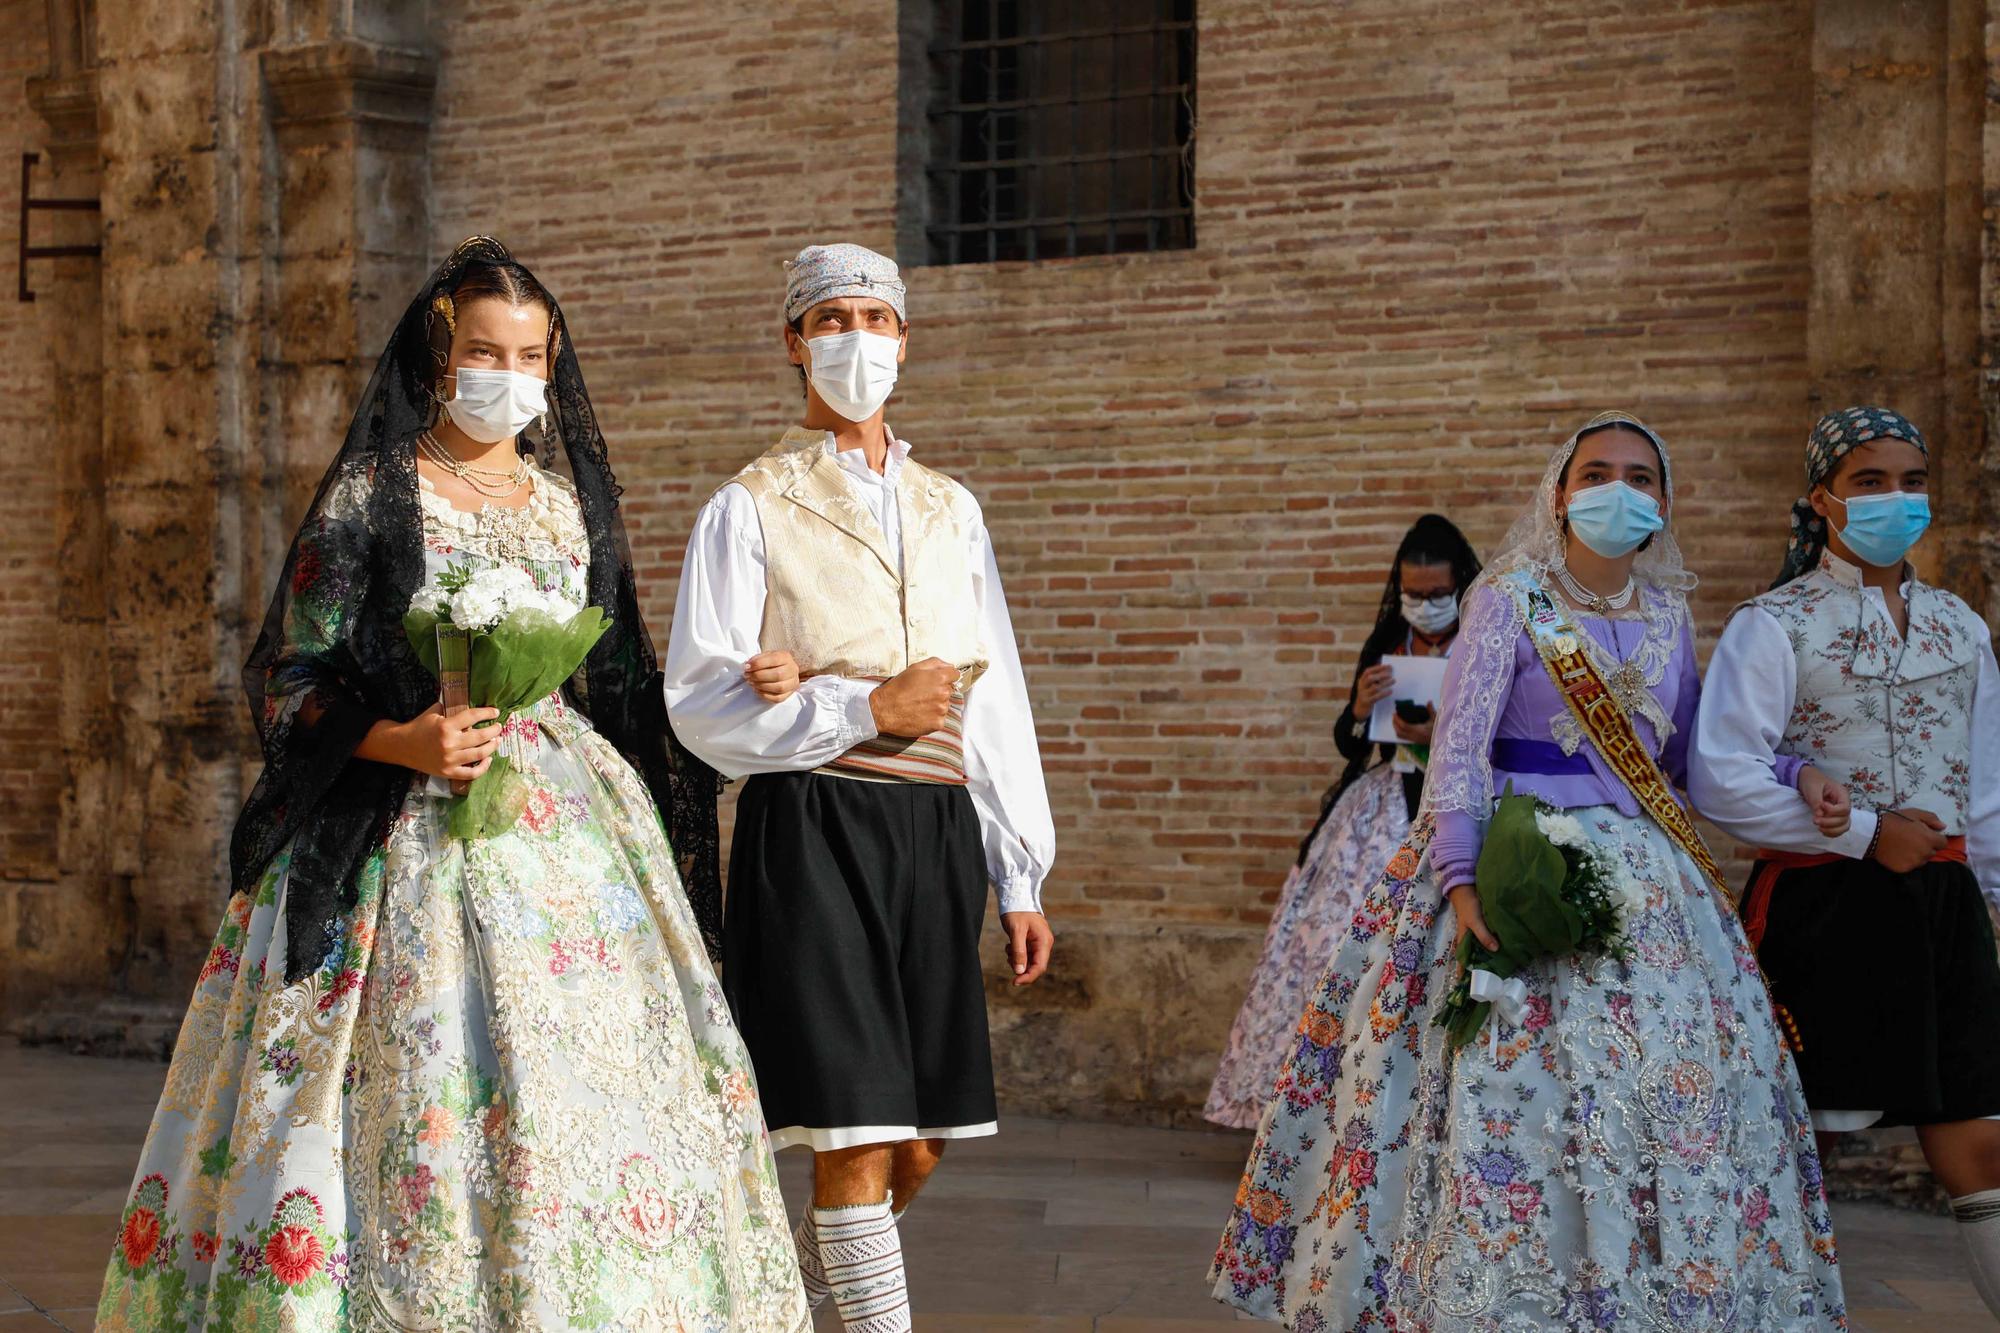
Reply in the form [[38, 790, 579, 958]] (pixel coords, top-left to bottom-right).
[[1748, 556, 1986, 835]]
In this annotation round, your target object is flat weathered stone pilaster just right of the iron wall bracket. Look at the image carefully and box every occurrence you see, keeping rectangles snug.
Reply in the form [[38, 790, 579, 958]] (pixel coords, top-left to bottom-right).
[[88, 0, 254, 999]]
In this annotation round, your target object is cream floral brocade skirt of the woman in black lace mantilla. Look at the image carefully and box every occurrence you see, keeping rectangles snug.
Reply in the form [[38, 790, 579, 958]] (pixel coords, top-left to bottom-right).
[[98, 701, 810, 1333]]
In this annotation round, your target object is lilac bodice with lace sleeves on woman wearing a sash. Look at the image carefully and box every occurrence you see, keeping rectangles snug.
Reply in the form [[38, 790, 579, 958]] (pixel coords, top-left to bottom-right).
[[1428, 584, 1702, 889]]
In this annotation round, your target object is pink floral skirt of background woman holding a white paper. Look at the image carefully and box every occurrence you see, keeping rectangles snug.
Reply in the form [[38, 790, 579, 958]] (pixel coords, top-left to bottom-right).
[[1202, 765, 1410, 1129]]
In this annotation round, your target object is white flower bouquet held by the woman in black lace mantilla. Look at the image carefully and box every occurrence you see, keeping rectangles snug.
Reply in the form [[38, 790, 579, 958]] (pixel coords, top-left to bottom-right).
[[402, 564, 610, 839]]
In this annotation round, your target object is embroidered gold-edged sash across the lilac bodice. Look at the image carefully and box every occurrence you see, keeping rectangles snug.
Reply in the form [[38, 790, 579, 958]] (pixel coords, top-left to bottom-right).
[[1500, 570, 1734, 903]]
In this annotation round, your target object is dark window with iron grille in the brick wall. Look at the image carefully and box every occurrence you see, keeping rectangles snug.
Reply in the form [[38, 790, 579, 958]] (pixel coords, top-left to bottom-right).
[[898, 0, 1194, 264]]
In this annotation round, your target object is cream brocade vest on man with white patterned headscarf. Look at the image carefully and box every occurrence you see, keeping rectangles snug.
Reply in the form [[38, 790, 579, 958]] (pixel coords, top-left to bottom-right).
[[734, 426, 988, 691]]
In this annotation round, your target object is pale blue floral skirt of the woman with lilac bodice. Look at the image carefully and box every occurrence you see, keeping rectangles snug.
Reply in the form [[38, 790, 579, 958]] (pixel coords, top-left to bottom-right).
[[1210, 807, 1846, 1333]]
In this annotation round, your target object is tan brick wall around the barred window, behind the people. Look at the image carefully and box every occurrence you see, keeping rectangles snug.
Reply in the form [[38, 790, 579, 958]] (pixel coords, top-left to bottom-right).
[[432, 0, 1810, 1119]]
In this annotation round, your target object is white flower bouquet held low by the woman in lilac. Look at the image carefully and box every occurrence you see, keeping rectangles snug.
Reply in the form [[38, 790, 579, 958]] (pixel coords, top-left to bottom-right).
[[1434, 787, 1646, 1051]]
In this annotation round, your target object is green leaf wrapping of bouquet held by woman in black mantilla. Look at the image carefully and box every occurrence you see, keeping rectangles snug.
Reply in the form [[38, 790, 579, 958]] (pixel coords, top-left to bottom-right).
[[402, 606, 610, 839]]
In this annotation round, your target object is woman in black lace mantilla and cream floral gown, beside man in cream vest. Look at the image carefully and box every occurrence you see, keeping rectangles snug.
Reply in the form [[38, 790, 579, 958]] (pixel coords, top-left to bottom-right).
[[98, 238, 808, 1333]]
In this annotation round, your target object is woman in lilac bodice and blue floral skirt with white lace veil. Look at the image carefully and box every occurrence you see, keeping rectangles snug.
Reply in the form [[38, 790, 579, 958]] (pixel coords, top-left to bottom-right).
[[1212, 414, 1846, 1333]]
